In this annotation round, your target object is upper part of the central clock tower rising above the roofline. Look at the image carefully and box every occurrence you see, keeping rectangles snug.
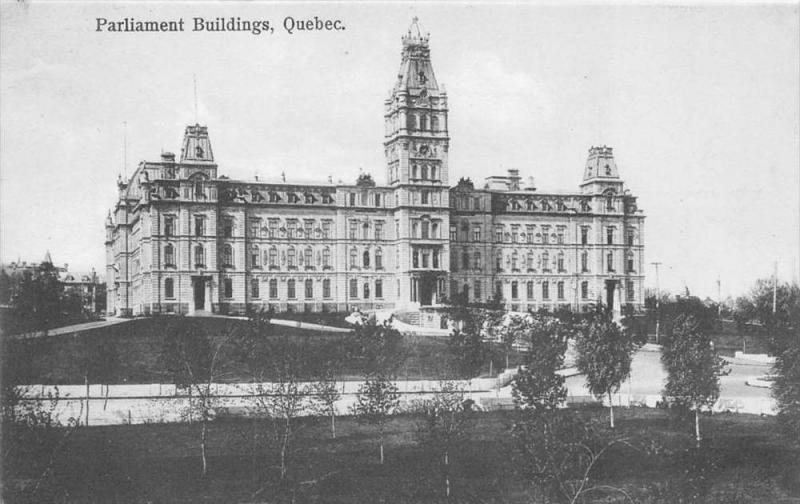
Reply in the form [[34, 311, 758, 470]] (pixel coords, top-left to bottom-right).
[[384, 18, 450, 187]]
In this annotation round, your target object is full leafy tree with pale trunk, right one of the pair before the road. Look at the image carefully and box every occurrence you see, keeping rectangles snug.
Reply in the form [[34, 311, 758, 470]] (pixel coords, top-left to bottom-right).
[[661, 315, 727, 446]]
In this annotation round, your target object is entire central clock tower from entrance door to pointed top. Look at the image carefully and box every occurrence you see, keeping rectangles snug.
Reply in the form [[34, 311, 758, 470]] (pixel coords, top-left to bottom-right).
[[383, 18, 450, 307]]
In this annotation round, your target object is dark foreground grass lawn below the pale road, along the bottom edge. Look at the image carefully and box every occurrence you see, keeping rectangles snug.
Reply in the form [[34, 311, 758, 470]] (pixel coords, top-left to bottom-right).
[[3, 408, 800, 504]]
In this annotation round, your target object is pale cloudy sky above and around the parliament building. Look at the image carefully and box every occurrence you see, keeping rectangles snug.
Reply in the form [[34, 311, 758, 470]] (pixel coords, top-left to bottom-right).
[[0, 0, 800, 297]]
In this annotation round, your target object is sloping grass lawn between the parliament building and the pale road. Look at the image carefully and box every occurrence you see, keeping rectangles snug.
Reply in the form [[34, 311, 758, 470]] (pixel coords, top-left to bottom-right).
[[0, 318, 521, 385]]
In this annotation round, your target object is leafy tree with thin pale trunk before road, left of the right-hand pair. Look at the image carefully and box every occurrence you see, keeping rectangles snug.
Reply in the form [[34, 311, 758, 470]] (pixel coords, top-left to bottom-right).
[[576, 317, 637, 429]]
